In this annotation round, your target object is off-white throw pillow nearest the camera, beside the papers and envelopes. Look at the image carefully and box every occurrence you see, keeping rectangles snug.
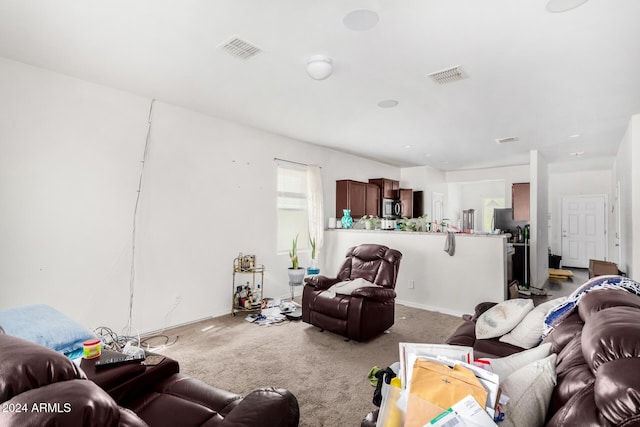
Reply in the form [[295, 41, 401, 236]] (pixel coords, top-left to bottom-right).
[[500, 354, 558, 427]]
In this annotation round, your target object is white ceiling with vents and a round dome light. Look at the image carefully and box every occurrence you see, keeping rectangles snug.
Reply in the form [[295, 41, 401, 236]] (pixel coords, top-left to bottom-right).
[[0, 0, 640, 170]]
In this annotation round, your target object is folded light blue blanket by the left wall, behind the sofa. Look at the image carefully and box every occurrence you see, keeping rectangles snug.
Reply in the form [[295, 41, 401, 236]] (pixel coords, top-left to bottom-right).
[[0, 304, 95, 358]]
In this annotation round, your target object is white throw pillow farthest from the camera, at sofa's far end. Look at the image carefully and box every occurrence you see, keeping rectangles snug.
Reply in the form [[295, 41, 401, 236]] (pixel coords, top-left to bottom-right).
[[476, 298, 533, 339]]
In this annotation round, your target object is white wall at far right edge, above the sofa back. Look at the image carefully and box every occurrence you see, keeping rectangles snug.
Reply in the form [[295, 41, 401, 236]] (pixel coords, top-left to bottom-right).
[[613, 114, 640, 280]]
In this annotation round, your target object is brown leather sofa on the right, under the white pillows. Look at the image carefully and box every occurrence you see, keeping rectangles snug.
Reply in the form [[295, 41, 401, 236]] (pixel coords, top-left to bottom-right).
[[447, 289, 640, 427]]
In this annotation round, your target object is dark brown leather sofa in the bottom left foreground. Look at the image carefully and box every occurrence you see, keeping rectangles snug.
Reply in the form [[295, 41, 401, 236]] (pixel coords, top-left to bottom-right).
[[0, 328, 299, 427]]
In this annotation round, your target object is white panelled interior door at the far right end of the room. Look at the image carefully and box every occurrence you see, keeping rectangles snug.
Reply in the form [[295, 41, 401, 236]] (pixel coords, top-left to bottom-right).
[[562, 195, 607, 268]]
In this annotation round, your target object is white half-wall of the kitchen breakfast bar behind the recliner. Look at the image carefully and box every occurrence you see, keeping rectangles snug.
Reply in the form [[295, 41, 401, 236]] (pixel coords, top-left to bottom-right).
[[320, 229, 509, 315]]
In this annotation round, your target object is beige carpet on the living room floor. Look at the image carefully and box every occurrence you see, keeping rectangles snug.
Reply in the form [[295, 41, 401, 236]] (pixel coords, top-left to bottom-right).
[[149, 305, 462, 427]]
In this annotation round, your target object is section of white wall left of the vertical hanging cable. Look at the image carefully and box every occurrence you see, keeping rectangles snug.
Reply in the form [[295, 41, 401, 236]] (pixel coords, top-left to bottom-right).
[[0, 59, 150, 327]]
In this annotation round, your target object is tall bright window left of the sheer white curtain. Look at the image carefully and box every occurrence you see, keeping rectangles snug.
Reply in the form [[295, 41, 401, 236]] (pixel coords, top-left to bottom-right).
[[277, 165, 309, 252]]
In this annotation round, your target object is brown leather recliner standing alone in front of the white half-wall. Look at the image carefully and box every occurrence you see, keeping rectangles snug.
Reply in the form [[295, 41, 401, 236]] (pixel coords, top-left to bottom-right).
[[302, 244, 402, 341]]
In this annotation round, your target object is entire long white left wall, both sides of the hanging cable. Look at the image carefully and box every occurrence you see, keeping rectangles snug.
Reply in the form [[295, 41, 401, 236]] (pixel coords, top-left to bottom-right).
[[0, 59, 400, 332]]
